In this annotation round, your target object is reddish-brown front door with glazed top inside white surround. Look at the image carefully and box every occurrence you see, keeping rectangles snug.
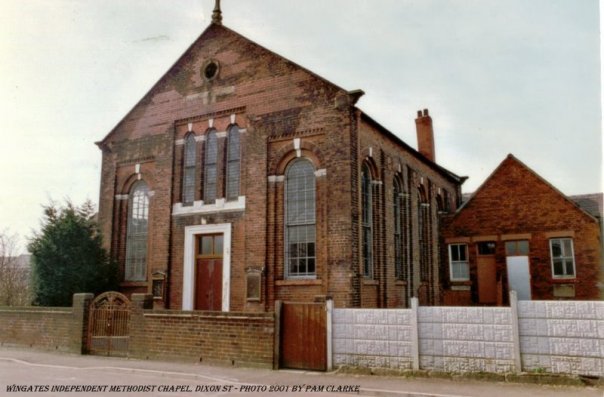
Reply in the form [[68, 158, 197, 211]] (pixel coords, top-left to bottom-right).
[[195, 234, 223, 311]]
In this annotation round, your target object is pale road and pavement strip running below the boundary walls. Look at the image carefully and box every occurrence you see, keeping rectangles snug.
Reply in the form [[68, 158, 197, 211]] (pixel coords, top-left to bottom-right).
[[0, 347, 604, 397]]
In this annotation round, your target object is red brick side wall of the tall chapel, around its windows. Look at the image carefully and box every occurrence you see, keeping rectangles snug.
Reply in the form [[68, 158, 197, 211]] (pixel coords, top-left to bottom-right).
[[357, 115, 459, 307]]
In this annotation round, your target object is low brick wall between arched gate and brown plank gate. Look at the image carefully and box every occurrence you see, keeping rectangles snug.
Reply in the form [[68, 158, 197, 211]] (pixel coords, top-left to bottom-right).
[[129, 294, 275, 368]]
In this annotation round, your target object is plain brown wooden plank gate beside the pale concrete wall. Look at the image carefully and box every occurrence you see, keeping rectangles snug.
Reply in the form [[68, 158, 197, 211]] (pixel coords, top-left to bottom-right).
[[280, 302, 327, 371]]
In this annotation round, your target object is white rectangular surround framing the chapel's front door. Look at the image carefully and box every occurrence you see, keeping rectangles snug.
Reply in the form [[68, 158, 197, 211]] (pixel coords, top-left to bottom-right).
[[182, 223, 231, 312]]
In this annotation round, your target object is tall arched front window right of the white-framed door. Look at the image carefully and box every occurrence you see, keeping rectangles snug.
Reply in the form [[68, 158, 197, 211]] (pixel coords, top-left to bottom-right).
[[285, 158, 316, 277]]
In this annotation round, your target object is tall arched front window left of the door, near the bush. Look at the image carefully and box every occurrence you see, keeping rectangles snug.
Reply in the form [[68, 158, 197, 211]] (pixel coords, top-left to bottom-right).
[[124, 181, 149, 281]]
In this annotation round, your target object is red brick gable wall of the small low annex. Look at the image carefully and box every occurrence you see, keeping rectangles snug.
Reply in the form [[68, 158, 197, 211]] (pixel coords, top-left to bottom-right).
[[442, 155, 600, 302]]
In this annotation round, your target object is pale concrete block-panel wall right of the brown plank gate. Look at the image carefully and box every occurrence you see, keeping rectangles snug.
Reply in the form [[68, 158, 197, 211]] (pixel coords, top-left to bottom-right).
[[332, 292, 604, 377]]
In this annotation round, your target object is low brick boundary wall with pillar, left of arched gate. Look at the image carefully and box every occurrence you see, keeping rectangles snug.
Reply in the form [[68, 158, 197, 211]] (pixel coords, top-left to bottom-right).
[[0, 294, 92, 353]]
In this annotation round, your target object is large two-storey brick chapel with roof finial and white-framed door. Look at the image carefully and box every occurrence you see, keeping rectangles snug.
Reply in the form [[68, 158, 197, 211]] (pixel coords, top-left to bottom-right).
[[98, 2, 464, 311]]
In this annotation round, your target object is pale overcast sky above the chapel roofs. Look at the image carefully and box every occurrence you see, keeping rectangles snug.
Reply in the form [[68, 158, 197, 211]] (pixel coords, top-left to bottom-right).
[[0, 0, 602, 252]]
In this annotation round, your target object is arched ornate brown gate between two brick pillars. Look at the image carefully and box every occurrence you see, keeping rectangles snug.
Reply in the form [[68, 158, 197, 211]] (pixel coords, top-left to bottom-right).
[[88, 292, 130, 356]]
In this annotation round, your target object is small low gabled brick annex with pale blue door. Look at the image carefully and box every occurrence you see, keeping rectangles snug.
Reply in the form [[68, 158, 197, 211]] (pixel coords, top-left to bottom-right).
[[441, 154, 602, 305]]
